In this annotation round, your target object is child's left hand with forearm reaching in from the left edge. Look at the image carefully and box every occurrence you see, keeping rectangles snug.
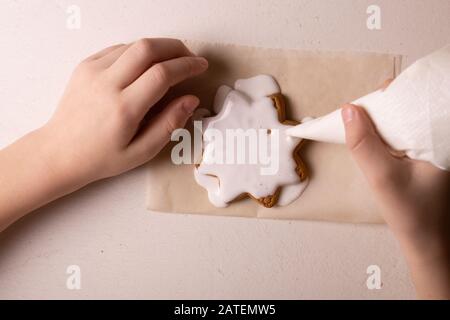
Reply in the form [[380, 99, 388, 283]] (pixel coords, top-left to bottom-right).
[[0, 39, 208, 232]]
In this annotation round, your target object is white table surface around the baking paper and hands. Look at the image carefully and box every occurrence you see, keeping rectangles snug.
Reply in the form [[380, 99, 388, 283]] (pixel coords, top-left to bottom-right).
[[0, 0, 450, 299]]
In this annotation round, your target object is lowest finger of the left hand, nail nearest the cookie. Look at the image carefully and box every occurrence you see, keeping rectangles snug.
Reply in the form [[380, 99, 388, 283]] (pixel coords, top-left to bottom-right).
[[128, 95, 199, 163]]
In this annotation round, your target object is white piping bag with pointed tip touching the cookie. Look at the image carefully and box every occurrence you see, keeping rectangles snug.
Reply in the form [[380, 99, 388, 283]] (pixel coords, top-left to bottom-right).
[[287, 45, 450, 171]]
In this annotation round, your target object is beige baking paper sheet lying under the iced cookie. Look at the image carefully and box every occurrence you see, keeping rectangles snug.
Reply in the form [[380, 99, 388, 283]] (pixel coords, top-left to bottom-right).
[[147, 42, 401, 223]]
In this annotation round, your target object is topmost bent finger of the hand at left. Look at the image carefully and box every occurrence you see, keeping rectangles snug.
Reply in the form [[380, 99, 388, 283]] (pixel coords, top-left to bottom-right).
[[110, 39, 193, 88]]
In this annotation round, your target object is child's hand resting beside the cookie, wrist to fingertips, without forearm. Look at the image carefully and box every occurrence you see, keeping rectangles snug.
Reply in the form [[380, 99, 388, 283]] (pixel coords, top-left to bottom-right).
[[44, 39, 208, 183]]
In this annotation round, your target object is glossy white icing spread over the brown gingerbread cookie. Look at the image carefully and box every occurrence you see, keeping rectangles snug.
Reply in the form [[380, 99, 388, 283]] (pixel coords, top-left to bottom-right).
[[194, 75, 307, 207]]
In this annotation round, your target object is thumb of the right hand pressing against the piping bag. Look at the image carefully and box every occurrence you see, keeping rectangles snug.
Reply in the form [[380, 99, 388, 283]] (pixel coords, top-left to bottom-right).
[[342, 104, 401, 187]]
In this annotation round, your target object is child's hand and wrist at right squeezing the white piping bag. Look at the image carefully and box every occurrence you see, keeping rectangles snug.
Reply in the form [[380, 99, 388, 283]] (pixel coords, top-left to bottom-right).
[[342, 80, 450, 298]]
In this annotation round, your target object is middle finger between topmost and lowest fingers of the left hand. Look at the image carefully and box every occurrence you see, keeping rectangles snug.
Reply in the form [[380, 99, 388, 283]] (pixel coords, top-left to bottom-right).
[[122, 57, 208, 118]]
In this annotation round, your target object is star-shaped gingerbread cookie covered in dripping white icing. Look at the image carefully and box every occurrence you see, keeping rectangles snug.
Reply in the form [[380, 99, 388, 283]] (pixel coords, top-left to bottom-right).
[[194, 75, 308, 208]]
